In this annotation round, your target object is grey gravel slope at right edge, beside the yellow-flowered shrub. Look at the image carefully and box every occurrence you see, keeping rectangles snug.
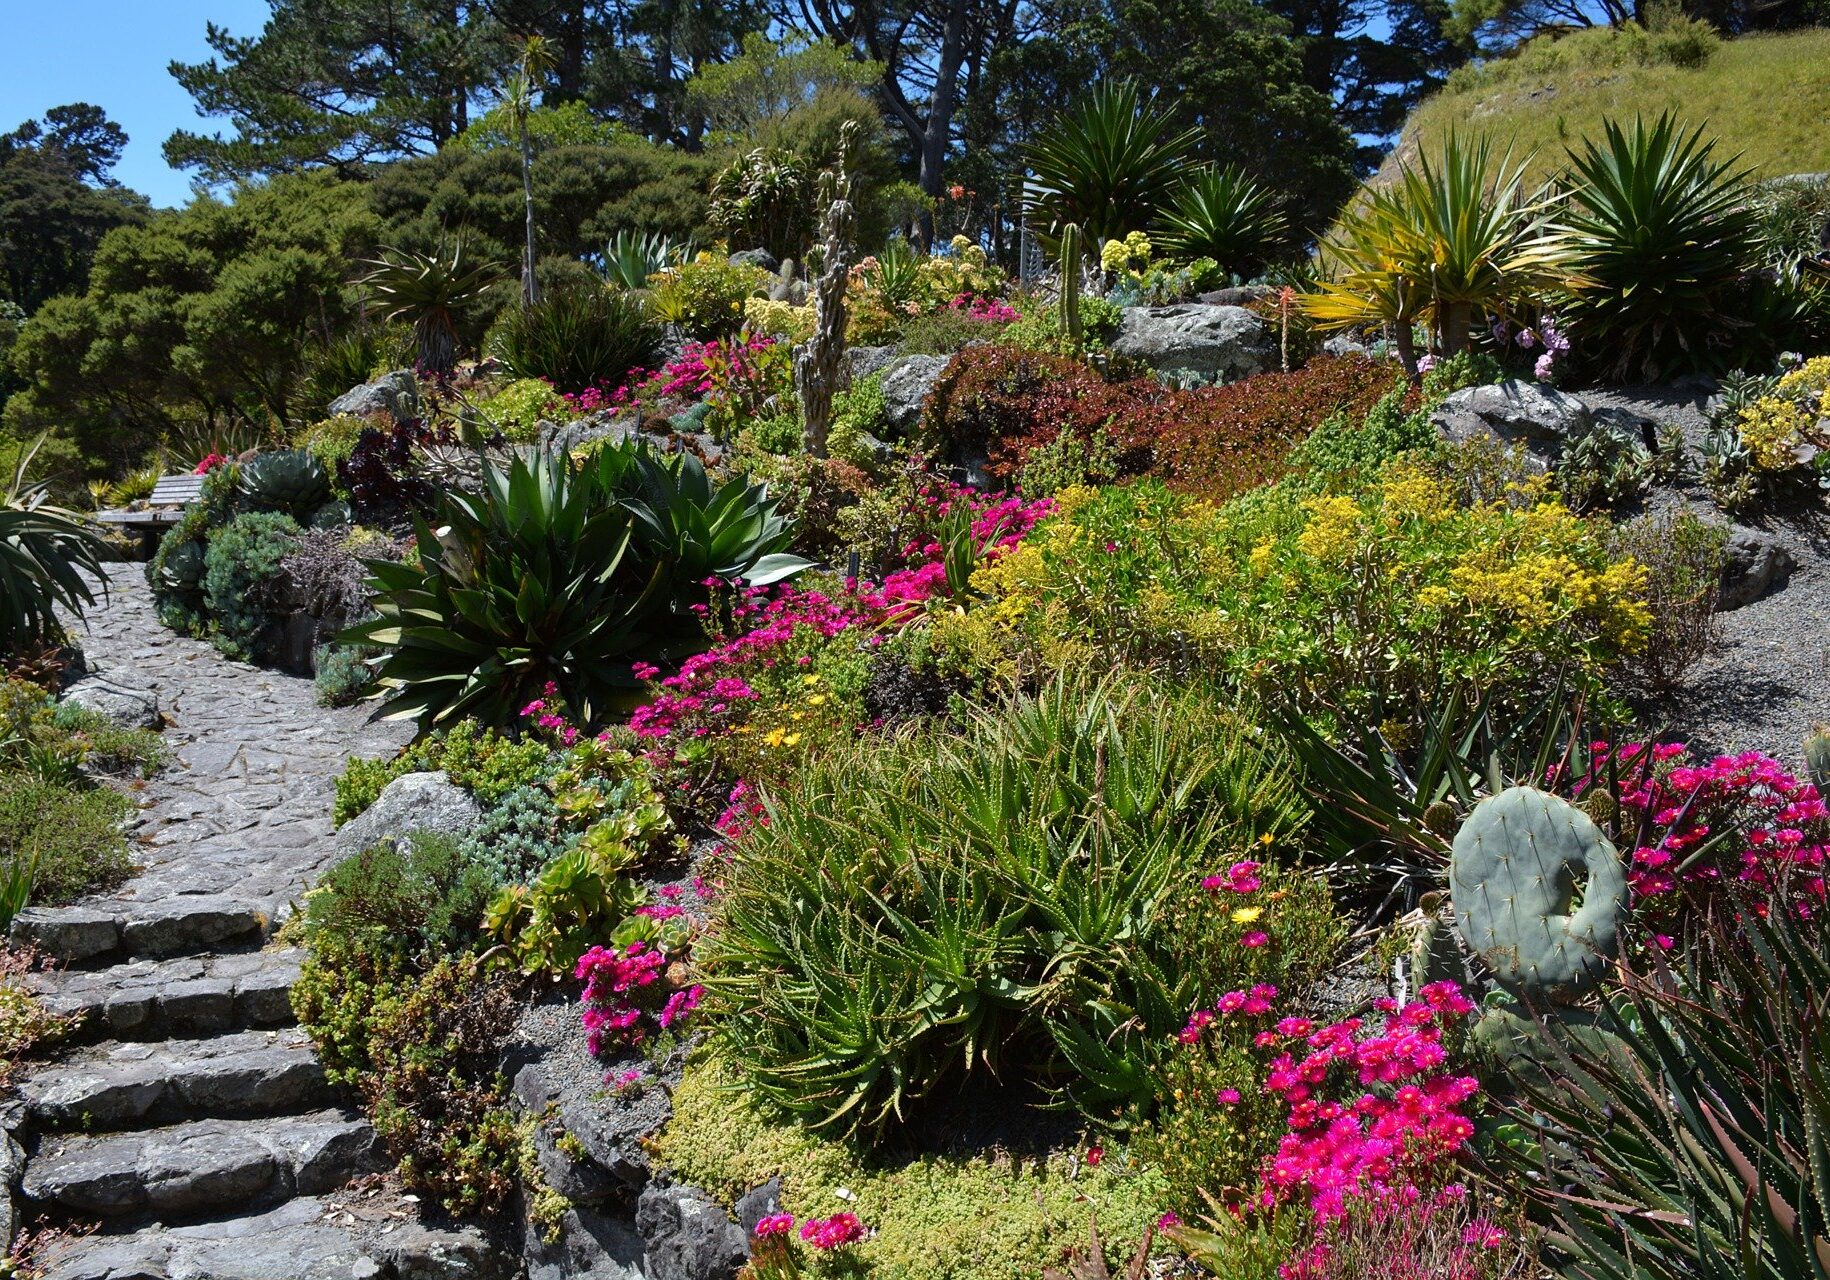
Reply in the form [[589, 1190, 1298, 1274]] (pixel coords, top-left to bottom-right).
[[1576, 377, 1830, 767]]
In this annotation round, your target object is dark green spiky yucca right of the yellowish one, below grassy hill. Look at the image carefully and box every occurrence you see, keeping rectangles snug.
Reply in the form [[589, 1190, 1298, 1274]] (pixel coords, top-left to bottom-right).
[[1561, 112, 1760, 381]]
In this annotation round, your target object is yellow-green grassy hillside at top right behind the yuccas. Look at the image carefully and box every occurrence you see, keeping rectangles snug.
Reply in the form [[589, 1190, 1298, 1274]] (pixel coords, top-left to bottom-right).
[[1385, 27, 1830, 178]]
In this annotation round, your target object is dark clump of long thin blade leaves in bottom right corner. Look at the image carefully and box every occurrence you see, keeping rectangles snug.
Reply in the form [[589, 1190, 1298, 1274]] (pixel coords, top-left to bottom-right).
[[1495, 886, 1830, 1280]]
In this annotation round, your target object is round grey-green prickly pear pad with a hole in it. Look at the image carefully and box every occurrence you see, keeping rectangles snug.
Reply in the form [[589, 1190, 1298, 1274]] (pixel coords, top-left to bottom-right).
[[1449, 787, 1627, 1000]]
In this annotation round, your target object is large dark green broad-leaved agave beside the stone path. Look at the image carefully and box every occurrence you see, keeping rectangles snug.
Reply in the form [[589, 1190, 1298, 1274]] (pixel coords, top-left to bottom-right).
[[340, 445, 807, 729]]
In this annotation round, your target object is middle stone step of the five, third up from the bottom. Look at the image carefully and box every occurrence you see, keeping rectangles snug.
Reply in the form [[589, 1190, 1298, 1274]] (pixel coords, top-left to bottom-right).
[[18, 1027, 333, 1132]]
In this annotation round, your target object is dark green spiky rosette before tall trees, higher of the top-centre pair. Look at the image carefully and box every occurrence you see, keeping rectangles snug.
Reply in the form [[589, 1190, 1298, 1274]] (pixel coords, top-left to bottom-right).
[[1023, 81, 1195, 244]]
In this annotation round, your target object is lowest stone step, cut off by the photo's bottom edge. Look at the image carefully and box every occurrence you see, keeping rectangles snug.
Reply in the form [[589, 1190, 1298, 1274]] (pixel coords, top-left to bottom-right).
[[37, 1196, 518, 1280]]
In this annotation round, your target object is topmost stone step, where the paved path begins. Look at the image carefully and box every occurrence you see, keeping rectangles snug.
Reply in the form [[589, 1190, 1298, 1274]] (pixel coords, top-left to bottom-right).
[[9, 894, 269, 965]]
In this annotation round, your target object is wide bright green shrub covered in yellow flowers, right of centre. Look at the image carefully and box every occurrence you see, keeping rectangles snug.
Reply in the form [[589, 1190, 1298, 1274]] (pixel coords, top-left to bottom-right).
[[979, 463, 1651, 721]]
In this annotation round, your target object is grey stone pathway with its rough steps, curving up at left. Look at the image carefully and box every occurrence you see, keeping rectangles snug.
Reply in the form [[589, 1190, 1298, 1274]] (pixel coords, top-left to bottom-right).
[[0, 564, 507, 1280]]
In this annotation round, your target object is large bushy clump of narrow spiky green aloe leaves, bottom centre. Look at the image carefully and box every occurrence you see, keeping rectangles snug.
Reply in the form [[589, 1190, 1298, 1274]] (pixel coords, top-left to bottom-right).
[[699, 681, 1330, 1134]]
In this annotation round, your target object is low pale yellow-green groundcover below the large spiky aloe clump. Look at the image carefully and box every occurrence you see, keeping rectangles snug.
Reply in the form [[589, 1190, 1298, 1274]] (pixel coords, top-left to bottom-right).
[[655, 1055, 1168, 1280]]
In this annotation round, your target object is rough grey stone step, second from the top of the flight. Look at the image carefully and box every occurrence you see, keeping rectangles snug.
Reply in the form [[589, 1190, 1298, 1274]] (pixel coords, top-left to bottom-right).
[[26, 947, 304, 1040]]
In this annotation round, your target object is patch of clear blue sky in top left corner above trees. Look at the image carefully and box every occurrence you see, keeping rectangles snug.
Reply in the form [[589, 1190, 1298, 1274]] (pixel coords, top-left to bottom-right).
[[0, 0, 267, 205]]
